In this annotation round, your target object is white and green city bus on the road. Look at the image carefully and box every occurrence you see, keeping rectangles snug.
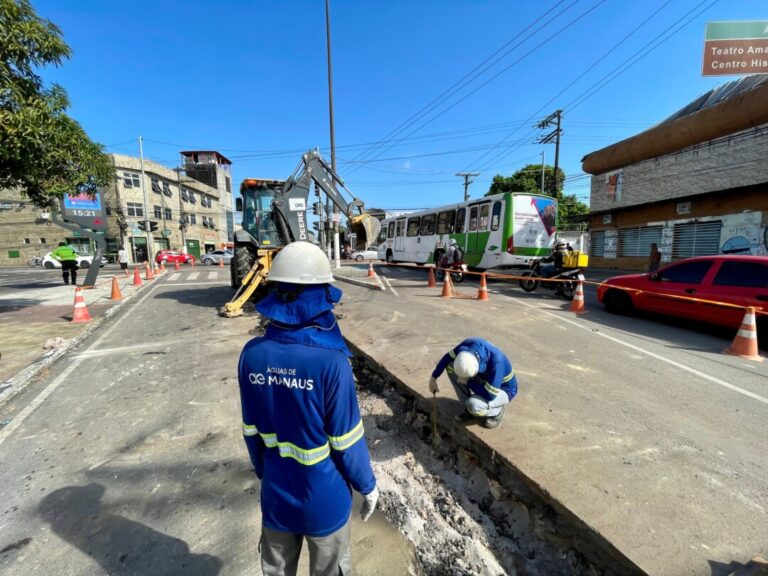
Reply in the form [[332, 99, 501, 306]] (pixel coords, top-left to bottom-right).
[[377, 192, 557, 269]]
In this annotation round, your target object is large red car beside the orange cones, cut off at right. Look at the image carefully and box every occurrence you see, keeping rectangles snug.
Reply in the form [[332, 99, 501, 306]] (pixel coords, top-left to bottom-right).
[[597, 255, 768, 338]]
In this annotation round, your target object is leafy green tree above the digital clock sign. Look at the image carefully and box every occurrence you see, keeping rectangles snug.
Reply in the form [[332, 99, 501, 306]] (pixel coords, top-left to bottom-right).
[[0, 0, 114, 207]]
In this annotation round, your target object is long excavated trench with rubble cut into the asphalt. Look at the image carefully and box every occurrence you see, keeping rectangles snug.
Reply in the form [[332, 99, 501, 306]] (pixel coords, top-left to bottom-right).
[[348, 343, 643, 576]]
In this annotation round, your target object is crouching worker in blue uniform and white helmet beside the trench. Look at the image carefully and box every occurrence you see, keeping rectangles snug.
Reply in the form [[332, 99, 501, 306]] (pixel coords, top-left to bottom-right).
[[429, 338, 517, 428]]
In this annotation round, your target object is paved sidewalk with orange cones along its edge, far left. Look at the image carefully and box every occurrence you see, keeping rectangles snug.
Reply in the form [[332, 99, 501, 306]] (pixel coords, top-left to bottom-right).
[[0, 269, 157, 404]]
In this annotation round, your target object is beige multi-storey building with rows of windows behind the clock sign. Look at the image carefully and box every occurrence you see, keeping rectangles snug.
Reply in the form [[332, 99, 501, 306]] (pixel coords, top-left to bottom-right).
[[0, 152, 234, 266]]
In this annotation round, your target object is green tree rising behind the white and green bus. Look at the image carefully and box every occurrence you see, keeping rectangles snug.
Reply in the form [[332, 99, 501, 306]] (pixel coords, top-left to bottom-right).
[[486, 164, 589, 229]]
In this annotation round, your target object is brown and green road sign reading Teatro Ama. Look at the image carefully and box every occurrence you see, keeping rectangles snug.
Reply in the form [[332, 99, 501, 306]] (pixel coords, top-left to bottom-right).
[[701, 20, 768, 76]]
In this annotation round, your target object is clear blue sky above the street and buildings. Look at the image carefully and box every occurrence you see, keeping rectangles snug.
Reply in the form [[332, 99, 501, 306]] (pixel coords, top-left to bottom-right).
[[39, 0, 768, 210]]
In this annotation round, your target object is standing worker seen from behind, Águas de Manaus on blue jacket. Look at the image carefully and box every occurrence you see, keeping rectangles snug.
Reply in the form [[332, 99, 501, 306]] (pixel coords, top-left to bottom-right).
[[238, 242, 379, 576]]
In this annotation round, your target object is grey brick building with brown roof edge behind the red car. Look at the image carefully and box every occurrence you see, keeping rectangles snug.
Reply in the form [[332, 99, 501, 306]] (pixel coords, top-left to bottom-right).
[[585, 79, 768, 271]]
